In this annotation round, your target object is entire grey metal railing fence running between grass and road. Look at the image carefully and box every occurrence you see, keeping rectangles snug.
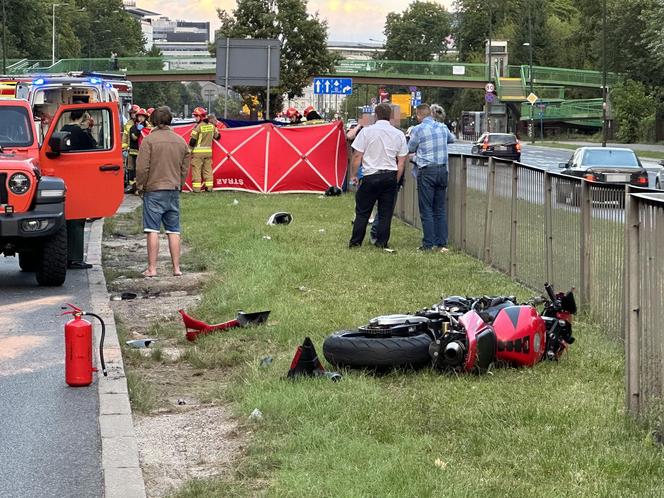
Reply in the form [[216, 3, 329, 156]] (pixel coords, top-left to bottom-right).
[[397, 154, 664, 424]]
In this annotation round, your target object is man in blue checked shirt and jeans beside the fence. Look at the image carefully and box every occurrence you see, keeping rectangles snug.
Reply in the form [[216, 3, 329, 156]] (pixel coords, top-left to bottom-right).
[[408, 104, 454, 253]]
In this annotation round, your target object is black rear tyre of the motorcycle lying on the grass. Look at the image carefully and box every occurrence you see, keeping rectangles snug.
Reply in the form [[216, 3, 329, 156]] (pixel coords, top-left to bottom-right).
[[323, 330, 432, 369]]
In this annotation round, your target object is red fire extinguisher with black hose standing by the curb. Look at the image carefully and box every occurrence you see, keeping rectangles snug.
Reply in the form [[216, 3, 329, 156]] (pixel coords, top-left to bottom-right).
[[63, 303, 108, 387]]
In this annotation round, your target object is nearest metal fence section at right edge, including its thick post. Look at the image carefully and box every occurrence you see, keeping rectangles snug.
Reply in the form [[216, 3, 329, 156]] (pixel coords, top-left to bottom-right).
[[624, 193, 664, 420]]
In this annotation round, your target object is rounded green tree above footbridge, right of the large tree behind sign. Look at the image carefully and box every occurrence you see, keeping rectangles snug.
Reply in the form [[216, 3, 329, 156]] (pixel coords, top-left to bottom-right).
[[383, 0, 451, 61]]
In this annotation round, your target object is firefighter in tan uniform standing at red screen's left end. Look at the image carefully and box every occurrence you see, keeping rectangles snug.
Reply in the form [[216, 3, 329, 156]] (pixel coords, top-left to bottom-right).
[[189, 107, 219, 192]]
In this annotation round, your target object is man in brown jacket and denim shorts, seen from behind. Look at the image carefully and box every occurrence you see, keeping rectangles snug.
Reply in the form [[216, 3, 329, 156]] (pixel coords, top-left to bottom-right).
[[136, 106, 189, 277]]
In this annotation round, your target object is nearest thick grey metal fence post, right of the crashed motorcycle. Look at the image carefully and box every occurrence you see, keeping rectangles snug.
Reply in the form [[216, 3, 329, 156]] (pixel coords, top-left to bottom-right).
[[623, 194, 641, 415]]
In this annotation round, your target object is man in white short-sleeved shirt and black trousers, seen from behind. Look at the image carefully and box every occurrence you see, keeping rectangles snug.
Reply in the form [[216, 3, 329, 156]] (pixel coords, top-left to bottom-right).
[[348, 104, 408, 248]]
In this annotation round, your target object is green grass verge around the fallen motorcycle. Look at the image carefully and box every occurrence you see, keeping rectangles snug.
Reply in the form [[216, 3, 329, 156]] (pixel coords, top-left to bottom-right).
[[170, 193, 664, 498]]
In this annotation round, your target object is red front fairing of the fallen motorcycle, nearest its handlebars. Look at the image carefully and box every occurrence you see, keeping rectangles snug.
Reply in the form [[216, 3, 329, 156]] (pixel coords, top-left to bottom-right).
[[493, 305, 546, 367]]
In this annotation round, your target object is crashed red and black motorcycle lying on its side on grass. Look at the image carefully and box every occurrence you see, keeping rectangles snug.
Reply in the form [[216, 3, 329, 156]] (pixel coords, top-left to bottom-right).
[[323, 284, 576, 373]]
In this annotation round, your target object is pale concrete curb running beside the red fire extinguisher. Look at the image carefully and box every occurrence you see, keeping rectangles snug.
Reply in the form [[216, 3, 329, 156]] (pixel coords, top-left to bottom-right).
[[87, 219, 146, 498]]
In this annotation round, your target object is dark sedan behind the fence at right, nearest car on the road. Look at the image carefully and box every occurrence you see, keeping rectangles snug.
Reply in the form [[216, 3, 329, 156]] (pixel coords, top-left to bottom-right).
[[556, 147, 648, 205]]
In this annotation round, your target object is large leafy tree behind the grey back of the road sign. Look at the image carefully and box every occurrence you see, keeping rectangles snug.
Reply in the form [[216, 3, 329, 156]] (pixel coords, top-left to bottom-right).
[[215, 0, 336, 115]]
